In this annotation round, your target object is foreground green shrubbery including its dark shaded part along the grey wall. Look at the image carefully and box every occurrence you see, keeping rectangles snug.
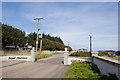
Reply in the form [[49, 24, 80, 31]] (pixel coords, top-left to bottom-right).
[[63, 62, 118, 80]]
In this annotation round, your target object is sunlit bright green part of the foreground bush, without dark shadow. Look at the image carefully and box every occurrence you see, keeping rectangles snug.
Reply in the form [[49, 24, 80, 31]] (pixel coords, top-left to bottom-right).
[[64, 62, 100, 80]]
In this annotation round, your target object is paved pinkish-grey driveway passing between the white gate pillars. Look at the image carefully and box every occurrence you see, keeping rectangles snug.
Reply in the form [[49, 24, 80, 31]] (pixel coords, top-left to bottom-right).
[[2, 54, 68, 78]]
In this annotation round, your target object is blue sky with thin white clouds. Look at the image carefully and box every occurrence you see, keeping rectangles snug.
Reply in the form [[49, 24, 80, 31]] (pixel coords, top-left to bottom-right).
[[2, 2, 118, 50]]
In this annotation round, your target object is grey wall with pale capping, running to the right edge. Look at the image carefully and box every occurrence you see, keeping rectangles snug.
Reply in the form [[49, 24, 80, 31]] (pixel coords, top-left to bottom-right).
[[92, 56, 120, 79]]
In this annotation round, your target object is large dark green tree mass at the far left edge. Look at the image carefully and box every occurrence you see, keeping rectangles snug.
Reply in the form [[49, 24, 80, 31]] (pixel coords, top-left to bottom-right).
[[2, 24, 26, 47]]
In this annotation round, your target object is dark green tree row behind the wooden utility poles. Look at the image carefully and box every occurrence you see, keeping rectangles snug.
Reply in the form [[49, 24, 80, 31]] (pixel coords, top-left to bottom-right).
[[27, 32, 70, 50]]
